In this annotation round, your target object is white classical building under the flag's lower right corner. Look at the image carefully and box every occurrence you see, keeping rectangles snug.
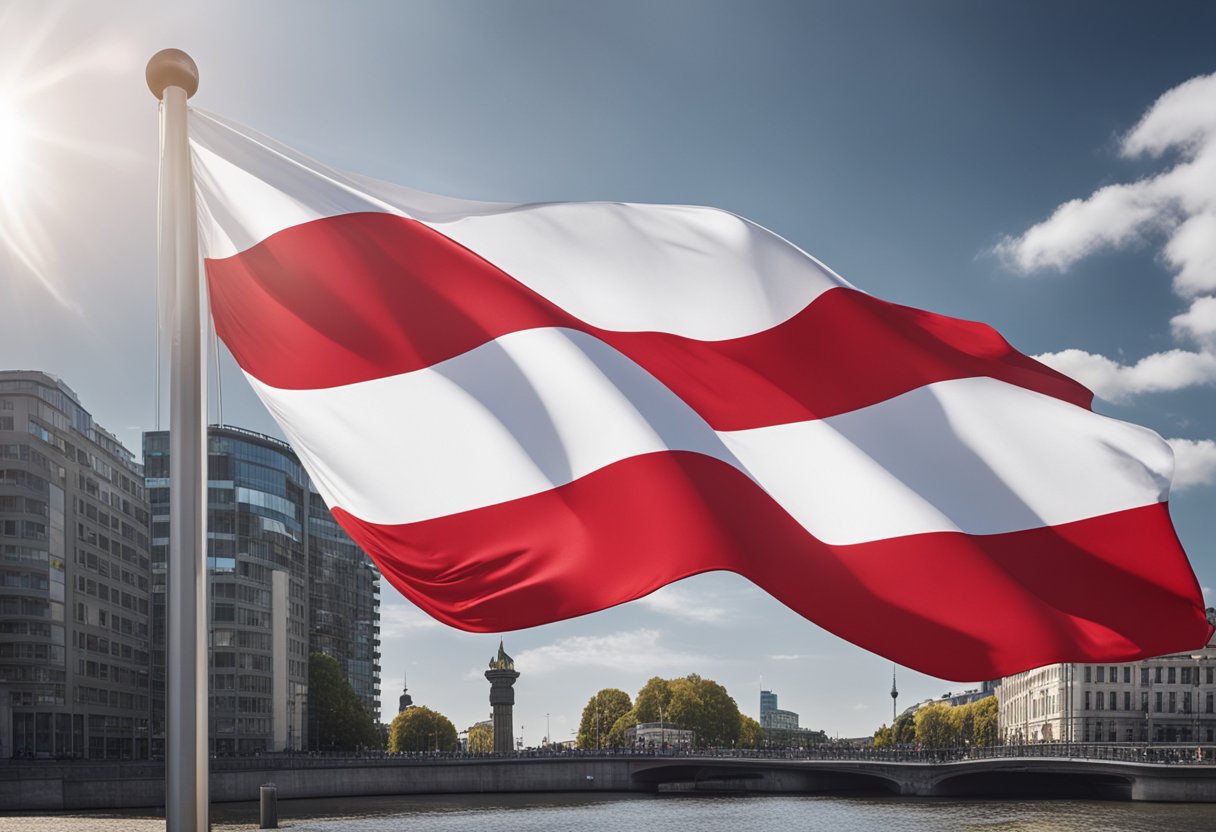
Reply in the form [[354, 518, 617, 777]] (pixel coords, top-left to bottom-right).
[[996, 609, 1216, 743]]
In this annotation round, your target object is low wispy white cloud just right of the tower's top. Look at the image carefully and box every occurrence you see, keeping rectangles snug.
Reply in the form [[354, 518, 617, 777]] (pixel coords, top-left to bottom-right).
[[516, 629, 713, 674]]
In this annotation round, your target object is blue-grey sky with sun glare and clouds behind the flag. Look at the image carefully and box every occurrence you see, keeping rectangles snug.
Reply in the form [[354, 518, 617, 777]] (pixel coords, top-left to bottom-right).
[[0, 0, 1216, 743]]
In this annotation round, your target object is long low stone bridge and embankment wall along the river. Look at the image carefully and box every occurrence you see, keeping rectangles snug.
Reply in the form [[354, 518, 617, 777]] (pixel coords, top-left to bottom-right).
[[0, 746, 1216, 811]]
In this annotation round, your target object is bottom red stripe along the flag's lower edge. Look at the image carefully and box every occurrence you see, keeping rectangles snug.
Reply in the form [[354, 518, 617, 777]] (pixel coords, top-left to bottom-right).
[[333, 451, 1211, 680]]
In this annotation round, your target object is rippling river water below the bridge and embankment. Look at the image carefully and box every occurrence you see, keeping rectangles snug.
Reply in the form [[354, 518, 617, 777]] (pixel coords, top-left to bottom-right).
[[0, 794, 1216, 832]]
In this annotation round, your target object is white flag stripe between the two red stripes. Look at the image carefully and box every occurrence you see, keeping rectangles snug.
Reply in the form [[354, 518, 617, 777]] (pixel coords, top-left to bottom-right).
[[249, 328, 1173, 544]]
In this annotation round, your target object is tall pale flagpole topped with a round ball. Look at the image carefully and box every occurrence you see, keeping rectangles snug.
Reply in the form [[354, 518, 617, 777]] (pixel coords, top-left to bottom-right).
[[147, 49, 210, 832]]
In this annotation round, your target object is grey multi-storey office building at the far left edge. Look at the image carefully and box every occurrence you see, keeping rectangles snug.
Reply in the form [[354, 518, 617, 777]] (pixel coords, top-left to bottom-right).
[[0, 371, 151, 759]]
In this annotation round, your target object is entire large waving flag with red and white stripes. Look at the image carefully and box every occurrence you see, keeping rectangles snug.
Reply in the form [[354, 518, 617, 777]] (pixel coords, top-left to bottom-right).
[[190, 111, 1211, 679]]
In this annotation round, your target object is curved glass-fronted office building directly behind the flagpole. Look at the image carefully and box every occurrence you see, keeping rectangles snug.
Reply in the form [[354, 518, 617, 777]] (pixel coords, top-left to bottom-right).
[[143, 427, 379, 754]]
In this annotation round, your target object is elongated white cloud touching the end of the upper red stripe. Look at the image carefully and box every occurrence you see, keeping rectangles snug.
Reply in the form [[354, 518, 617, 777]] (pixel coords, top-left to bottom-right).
[[1035, 349, 1216, 401]]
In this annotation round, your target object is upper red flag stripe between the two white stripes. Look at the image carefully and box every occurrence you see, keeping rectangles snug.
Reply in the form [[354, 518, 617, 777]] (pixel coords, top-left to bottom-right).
[[207, 213, 1092, 431]]
